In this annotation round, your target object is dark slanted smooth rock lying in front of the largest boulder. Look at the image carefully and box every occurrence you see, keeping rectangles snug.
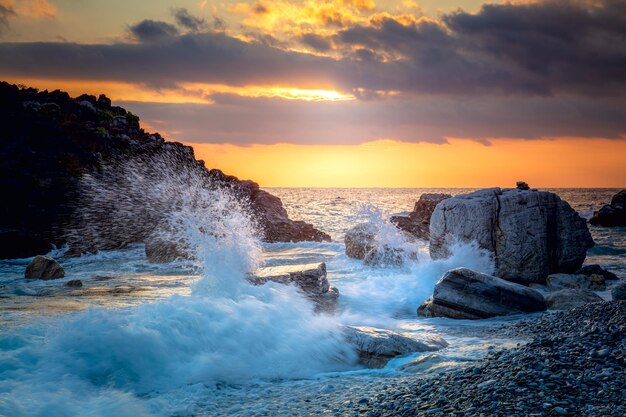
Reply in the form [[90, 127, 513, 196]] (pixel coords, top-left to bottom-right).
[[418, 268, 546, 319]]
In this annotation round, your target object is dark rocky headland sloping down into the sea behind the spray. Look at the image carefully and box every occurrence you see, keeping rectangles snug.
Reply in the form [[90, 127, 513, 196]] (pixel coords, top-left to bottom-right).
[[0, 83, 330, 259]]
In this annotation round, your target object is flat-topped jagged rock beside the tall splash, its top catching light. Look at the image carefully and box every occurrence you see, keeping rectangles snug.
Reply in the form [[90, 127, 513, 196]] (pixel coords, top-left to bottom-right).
[[248, 262, 339, 312]]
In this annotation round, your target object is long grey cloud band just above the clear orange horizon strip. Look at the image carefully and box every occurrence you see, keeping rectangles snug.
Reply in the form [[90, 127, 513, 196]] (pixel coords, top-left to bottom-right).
[[122, 94, 626, 145]]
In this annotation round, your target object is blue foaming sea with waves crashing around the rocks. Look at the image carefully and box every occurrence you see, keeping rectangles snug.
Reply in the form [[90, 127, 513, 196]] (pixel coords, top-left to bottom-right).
[[0, 188, 626, 416]]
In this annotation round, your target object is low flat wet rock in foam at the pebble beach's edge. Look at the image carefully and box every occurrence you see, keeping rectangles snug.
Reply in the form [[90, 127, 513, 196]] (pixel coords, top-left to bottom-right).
[[344, 326, 448, 368]]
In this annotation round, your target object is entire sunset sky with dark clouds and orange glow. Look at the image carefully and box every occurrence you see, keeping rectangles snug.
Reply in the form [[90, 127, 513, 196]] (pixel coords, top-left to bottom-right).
[[0, 0, 626, 188]]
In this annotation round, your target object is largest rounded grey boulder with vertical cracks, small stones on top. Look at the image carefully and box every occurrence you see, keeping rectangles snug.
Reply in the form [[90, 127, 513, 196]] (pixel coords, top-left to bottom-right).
[[430, 188, 593, 284]]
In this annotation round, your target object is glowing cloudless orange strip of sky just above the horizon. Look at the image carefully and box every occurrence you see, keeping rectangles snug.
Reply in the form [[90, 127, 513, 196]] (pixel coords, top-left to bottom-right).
[[190, 138, 626, 188]]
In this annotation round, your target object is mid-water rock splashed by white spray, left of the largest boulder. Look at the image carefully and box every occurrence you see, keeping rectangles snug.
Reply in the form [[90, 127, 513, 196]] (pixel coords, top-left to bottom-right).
[[344, 223, 416, 267]]
